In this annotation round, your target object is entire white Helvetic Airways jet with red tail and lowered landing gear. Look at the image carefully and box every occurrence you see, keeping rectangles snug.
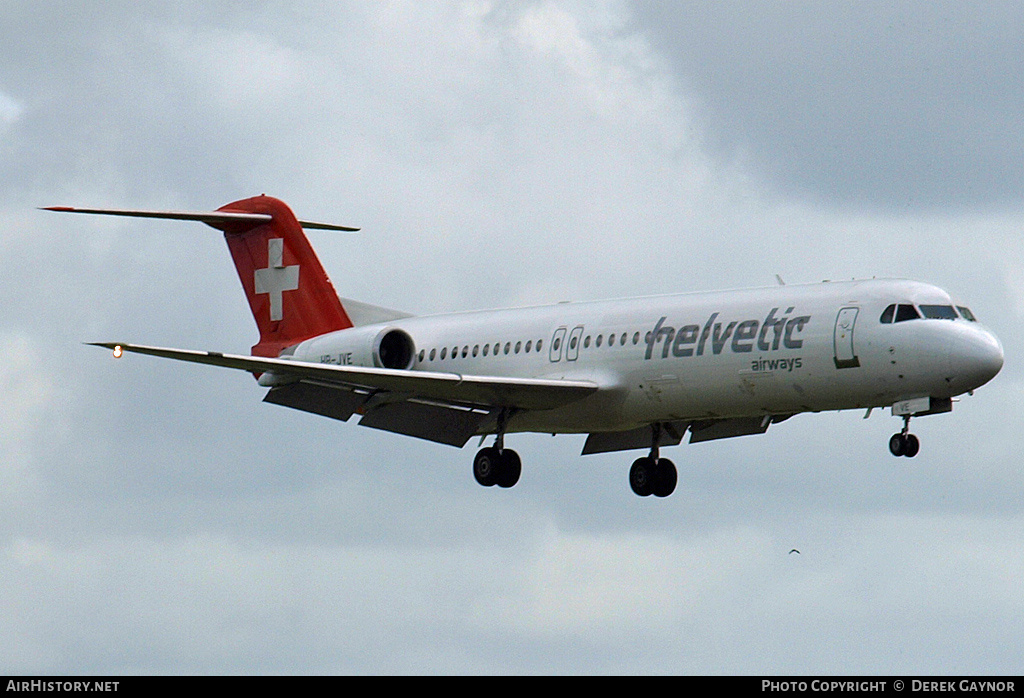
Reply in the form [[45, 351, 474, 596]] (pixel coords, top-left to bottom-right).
[[49, 195, 1004, 496]]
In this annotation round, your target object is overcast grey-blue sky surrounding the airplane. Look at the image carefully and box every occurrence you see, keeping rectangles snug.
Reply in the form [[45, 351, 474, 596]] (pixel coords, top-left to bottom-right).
[[0, 0, 1024, 673]]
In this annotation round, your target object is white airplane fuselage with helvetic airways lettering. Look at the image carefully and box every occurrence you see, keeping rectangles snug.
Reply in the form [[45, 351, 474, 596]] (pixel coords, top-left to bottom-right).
[[294, 280, 1002, 433]]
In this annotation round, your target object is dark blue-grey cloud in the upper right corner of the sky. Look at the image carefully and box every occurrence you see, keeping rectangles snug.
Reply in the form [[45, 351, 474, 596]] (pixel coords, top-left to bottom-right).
[[632, 2, 1024, 211]]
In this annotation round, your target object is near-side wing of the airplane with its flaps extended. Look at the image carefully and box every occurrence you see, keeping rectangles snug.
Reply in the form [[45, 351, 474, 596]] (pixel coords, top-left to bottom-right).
[[92, 342, 598, 446]]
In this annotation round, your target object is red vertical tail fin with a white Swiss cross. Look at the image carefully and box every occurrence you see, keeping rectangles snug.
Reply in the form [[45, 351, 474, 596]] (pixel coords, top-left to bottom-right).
[[209, 197, 352, 357]]
